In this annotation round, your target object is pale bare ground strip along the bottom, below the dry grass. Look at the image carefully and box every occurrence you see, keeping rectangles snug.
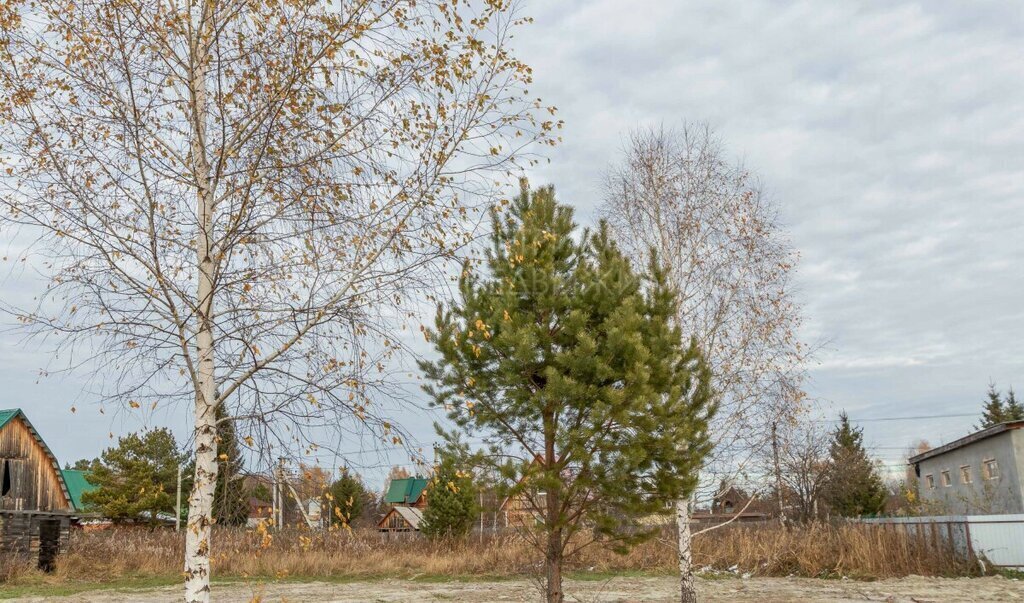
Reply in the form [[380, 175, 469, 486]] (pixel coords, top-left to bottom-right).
[[4, 576, 1024, 603]]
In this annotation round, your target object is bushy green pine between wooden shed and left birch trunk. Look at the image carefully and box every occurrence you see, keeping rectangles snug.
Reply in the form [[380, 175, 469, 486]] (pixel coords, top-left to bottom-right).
[[82, 429, 186, 524]]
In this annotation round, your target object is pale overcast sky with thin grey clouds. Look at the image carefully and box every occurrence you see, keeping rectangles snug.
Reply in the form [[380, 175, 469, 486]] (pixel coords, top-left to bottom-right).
[[0, 0, 1024, 481]]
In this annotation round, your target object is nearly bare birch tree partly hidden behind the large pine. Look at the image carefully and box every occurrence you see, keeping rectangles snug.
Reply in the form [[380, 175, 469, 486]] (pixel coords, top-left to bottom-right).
[[603, 124, 807, 602]]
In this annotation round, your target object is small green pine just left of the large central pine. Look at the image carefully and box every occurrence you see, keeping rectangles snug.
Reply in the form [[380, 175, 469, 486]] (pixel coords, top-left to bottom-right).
[[420, 454, 479, 539]]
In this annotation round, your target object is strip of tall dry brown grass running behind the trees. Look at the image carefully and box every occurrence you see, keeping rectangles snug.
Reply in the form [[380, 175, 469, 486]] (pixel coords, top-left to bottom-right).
[[0, 524, 976, 584]]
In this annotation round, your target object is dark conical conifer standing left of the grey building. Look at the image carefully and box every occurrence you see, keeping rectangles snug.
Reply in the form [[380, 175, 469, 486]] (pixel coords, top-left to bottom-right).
[[824, 413, 886, 517]]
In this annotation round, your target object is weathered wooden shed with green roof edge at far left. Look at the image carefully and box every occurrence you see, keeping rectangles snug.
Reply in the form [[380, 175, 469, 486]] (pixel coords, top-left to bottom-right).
[[0, 408, 76, 569]]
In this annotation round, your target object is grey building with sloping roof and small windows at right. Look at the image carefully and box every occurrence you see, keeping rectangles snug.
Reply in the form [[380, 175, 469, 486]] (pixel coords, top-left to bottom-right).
[[909, 421, 1024, 515]]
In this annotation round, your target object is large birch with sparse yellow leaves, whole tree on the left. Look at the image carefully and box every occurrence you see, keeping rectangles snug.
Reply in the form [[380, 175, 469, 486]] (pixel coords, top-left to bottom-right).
[[0, 0, 559, 601]]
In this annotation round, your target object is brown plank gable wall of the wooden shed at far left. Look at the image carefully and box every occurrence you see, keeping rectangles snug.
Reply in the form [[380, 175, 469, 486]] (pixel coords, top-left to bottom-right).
[[0, 418, 72, 511]]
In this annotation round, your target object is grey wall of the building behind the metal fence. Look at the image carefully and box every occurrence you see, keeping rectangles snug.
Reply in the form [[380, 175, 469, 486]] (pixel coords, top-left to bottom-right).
[[918, 429, 1024, 514]]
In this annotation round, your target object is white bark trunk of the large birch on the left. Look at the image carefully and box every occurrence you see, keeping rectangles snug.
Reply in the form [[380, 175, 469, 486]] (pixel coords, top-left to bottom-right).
[[184, 3, 217, 603]]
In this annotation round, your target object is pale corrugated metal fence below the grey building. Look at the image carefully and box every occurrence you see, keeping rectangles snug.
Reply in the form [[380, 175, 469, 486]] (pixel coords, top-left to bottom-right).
[[858, 515, 1024, 569]]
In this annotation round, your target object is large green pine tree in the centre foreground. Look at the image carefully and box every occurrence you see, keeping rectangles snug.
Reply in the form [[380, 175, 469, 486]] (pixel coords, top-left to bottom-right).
[[422, 182, 715, 602]]
